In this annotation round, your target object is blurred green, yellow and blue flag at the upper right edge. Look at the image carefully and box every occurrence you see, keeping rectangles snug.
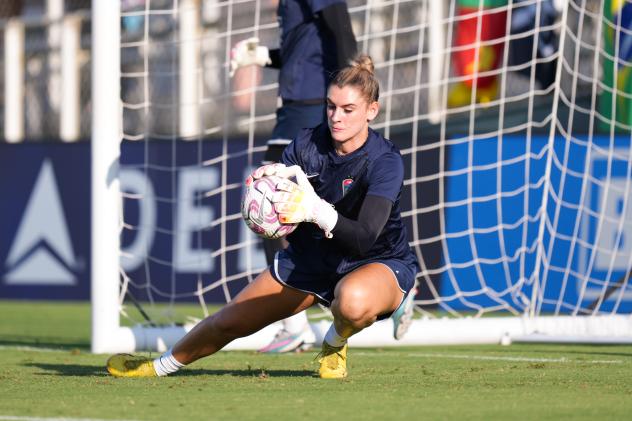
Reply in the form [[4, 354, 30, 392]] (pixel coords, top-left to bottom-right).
[[599, 0, 632, 133]]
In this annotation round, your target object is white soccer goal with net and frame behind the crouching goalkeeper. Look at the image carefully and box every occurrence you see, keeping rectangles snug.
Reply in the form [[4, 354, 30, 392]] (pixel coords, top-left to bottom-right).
[[93, 0, 632, 352]]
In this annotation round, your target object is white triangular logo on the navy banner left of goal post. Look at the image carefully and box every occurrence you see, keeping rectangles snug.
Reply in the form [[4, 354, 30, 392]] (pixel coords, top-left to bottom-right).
[[4, 160, 77, 285]]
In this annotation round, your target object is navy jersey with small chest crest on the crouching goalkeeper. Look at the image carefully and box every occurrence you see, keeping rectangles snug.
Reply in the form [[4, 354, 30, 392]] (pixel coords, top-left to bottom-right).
[[282, 124, 418, 274]]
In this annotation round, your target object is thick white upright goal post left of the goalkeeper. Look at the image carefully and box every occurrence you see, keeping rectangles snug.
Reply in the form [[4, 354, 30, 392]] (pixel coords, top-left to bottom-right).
[[91, 1, 126, 353]]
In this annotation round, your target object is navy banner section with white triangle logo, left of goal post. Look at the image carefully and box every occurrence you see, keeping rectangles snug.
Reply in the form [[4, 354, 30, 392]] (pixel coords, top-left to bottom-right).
[[0, 143, 90, 299]]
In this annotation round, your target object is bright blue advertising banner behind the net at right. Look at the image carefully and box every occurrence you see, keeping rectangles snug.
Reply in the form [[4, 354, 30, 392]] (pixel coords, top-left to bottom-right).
[[441, 136, 632, 313]]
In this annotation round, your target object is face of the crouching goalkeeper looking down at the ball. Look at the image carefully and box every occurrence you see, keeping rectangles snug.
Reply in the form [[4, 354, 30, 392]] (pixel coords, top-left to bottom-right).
[[327, 85, 379, 148]]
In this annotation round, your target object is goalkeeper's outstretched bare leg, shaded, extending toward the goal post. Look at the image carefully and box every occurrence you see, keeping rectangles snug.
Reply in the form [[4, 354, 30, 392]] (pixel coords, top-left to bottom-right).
[[172, 269, 316, 364]]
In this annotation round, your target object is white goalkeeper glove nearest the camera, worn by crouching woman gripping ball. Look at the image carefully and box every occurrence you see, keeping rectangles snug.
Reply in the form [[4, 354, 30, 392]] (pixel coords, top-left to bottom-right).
[[272, 165, 338, 238]]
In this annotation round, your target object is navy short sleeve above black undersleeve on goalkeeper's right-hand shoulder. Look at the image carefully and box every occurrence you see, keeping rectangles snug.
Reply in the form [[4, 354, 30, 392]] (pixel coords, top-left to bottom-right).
[[367, 152, 404, 203]]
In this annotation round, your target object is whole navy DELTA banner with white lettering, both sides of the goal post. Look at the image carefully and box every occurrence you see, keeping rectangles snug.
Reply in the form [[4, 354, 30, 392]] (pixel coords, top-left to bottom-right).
[[0, 140, 265, 302]]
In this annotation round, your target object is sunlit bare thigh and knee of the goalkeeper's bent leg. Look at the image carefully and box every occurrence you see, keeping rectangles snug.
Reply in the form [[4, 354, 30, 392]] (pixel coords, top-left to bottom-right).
[[334, 263, 404, 316]]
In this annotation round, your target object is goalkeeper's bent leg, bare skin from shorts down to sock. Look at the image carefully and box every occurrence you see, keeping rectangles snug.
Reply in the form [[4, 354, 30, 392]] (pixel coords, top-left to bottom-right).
[[331, 263, 404, 338]]
